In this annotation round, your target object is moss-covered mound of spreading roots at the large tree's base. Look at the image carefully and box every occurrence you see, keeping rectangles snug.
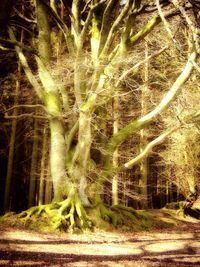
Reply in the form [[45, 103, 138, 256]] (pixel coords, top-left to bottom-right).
[[0, 200, 152, 233]]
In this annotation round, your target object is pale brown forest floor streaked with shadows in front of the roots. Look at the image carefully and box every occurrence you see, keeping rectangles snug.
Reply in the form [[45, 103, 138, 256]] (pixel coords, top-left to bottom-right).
[[0, 210, 200, 267]]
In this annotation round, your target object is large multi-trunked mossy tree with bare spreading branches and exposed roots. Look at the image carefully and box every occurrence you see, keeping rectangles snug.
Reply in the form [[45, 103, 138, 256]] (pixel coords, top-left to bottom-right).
[[1, 0, 198, 228]]
